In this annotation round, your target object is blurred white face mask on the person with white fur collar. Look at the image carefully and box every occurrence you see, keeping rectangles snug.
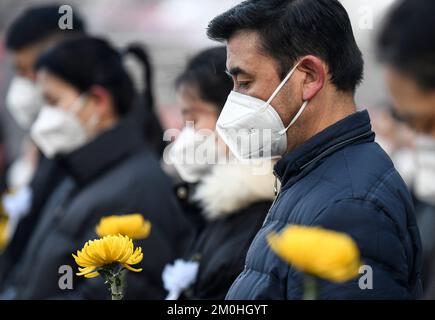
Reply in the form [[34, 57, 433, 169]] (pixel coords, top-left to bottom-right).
[[169, 126, 225, 183]]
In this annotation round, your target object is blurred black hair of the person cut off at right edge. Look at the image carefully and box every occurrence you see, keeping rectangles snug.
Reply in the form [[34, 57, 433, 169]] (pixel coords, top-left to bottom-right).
[[377, 0, 435, 90]]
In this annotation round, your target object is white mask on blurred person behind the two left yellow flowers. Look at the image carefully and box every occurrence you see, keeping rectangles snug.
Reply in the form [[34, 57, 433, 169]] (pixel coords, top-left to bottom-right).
[[30, 96, 97, 158]]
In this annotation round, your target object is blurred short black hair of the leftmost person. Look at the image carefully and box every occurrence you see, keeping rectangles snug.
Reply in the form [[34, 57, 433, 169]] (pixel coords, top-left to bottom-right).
[[6, 5, 85, 51]]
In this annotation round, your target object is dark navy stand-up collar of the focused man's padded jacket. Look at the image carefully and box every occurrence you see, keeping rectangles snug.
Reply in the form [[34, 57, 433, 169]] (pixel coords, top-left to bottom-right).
[[274, 110, 375, 187]]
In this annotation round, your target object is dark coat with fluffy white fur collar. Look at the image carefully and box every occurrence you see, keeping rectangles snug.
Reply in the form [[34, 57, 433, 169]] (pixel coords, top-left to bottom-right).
[[174, 164, 274, 300]]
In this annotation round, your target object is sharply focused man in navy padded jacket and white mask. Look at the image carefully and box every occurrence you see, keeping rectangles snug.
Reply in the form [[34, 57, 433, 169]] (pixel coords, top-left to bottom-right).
[[207, 0, 421, 299]]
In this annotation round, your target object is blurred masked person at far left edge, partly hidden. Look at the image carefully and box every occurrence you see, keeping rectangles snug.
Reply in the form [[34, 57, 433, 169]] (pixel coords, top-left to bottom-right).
[[0, 5, 85, 283]]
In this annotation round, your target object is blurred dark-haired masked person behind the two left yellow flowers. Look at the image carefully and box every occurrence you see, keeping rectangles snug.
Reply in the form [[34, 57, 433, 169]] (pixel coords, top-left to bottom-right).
[[3, 37, 191, 299]]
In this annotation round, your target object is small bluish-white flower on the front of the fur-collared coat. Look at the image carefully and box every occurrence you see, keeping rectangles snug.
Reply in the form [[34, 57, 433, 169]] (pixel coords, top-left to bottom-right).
[[162, 259, 199, 300]]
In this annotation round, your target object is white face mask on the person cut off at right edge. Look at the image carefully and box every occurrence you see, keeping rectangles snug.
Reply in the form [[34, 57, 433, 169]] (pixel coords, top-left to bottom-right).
[[414, 136, 435, 205]]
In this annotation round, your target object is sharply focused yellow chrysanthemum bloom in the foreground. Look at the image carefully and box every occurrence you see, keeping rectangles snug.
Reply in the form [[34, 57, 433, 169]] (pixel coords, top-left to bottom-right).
[[73, 235, 143, 278]]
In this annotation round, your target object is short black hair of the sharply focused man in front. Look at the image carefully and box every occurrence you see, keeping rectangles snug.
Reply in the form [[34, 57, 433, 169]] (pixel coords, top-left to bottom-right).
[[207, 0, 364, 92]]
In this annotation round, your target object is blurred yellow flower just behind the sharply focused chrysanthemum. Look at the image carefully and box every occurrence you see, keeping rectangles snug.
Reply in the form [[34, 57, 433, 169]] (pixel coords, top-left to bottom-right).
[[95, 213, 151, 240]]
